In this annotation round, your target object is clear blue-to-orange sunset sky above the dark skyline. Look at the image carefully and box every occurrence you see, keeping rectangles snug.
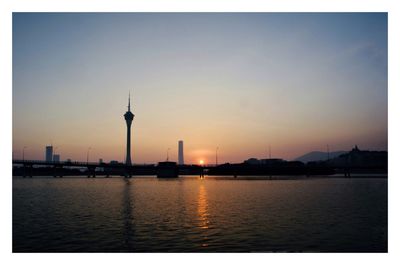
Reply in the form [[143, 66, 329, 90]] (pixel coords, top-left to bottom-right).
[[12, 13, 388, 163]]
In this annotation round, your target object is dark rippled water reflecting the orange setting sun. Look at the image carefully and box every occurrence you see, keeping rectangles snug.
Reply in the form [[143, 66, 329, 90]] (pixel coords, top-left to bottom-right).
[[13, 177, 387, 252]]
